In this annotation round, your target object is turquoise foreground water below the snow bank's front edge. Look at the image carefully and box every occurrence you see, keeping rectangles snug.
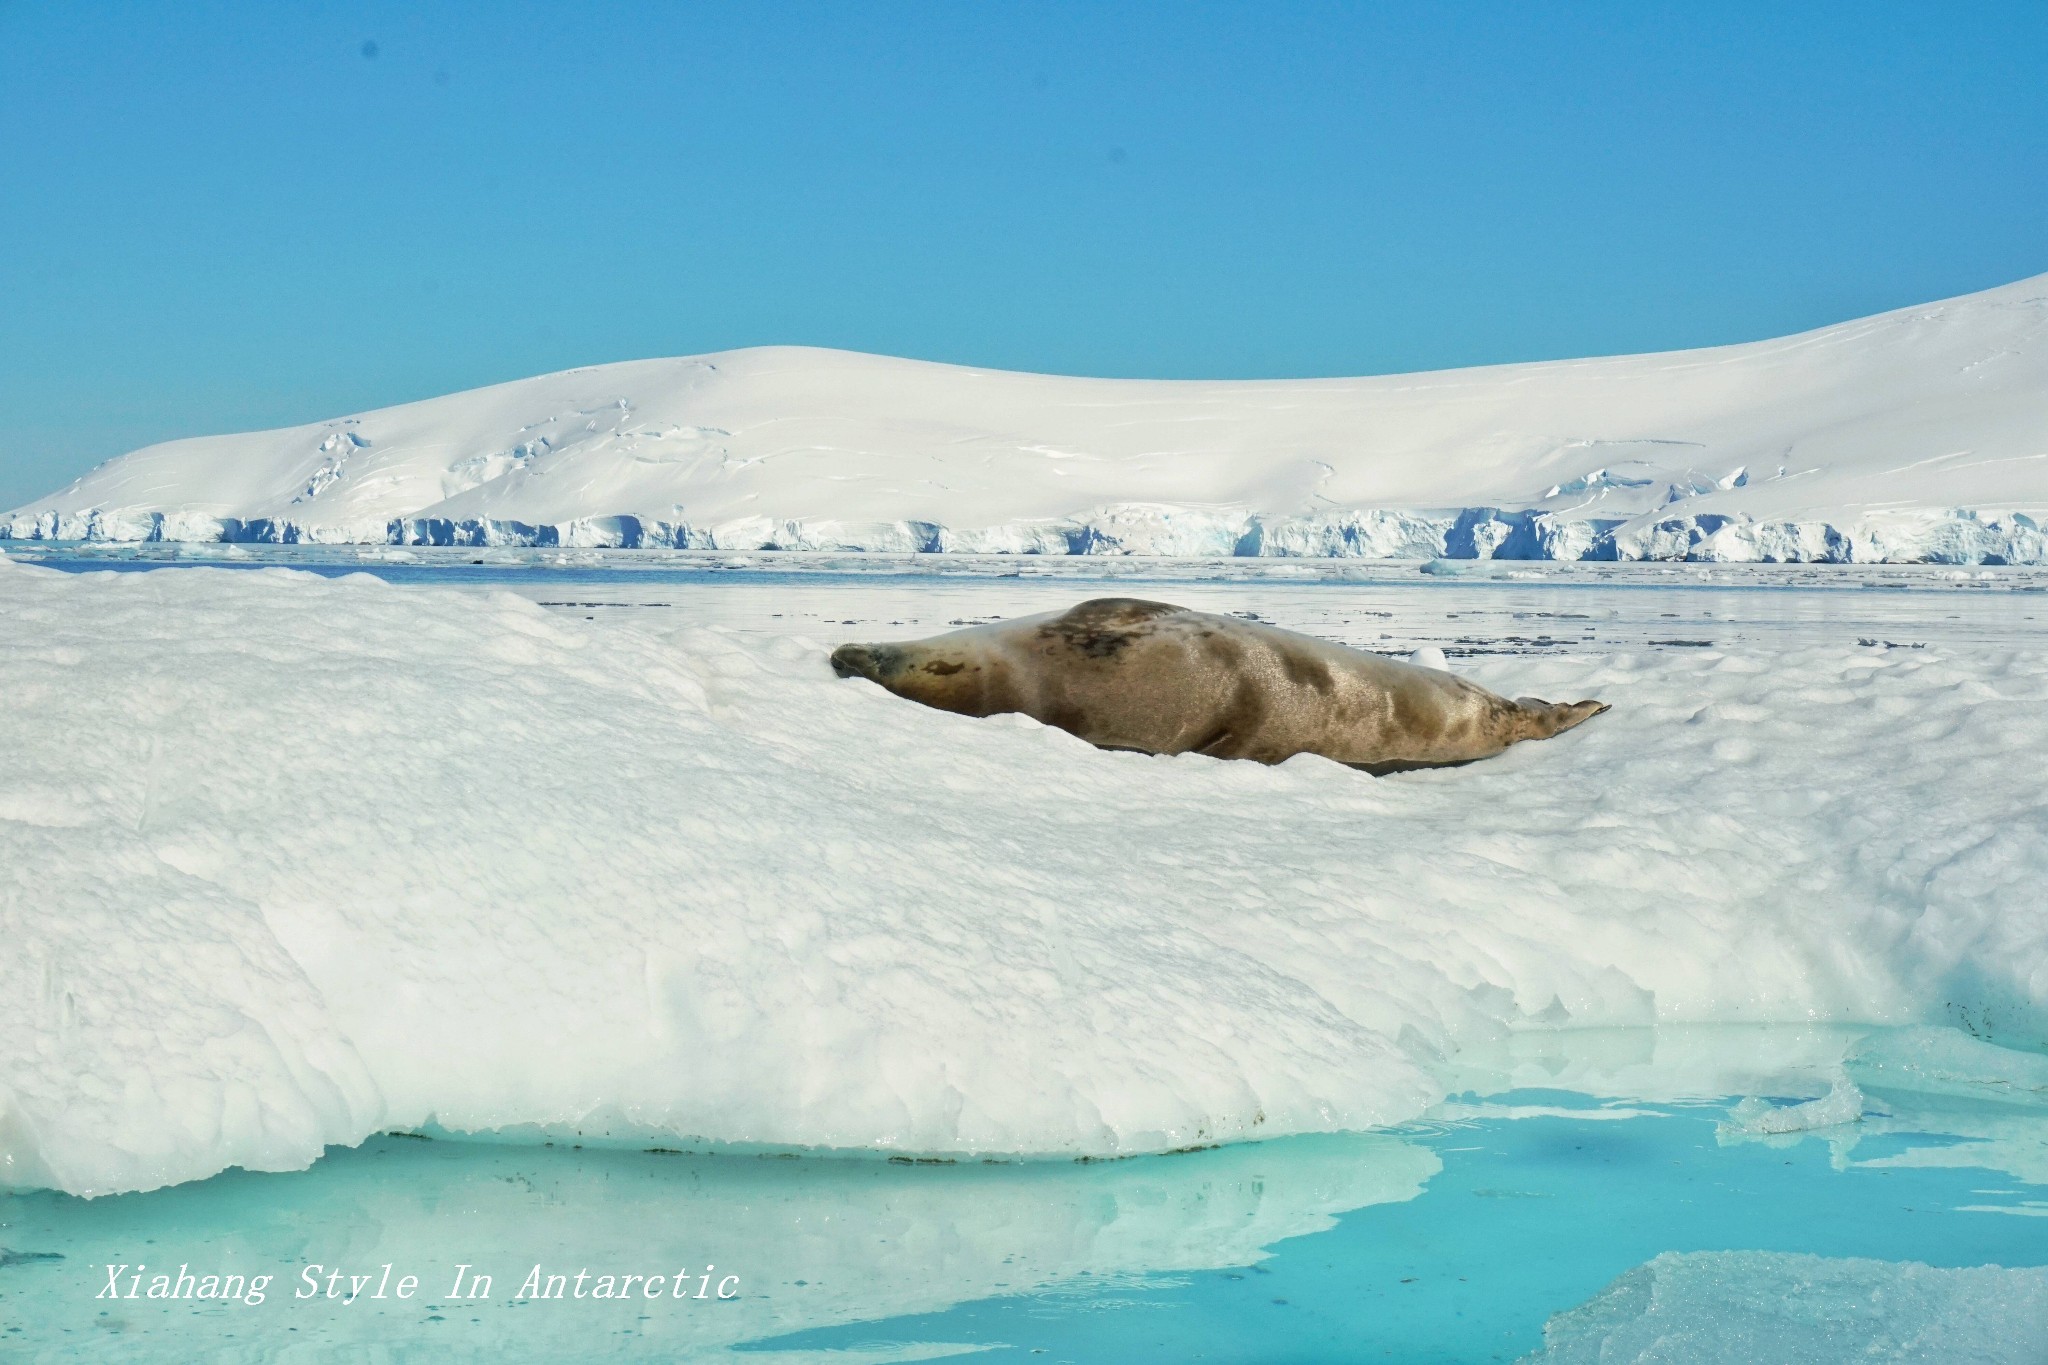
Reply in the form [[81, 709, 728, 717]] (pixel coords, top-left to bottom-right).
[[0, 1029, 2048, 1365]]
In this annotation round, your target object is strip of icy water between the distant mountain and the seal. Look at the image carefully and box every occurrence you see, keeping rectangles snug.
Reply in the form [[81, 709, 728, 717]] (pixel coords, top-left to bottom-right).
[[8, 542, 2048, 659]]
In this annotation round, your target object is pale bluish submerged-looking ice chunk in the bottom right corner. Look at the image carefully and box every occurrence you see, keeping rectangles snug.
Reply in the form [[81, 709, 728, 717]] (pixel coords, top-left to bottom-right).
[[1524, 1250, 2048, 1365]]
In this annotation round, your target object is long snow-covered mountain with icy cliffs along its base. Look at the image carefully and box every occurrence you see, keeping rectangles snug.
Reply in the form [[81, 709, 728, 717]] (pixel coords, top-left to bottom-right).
[[12, 274, 2048, 563]]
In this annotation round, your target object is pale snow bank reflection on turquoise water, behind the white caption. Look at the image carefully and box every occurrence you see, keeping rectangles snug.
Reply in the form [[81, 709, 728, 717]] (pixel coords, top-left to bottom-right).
[[0, 1136, 1438, 1361]]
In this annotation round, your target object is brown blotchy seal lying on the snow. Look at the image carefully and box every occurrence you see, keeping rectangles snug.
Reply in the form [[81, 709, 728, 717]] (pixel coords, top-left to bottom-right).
[[831, 598, 1608, 774]]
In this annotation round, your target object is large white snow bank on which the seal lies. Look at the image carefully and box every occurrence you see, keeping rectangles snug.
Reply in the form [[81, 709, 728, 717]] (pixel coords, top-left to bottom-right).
[[0, 561, 2048, 1193]]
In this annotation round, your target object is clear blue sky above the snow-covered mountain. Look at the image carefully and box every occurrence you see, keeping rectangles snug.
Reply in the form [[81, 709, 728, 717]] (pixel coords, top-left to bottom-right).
[[0, 0, 2048, 508]]
